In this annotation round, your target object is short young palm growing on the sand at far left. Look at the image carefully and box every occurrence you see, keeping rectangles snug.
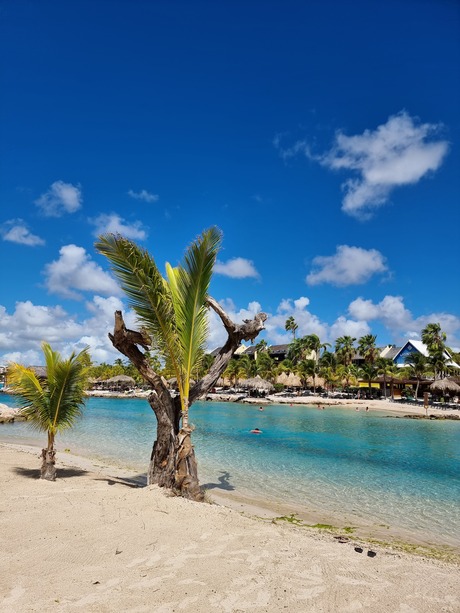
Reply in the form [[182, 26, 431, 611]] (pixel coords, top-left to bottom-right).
[[8, 343, 89, 481]]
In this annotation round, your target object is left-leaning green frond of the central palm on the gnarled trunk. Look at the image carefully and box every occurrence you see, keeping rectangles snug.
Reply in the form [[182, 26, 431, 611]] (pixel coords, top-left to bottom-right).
[[95, 234, 179, 368]]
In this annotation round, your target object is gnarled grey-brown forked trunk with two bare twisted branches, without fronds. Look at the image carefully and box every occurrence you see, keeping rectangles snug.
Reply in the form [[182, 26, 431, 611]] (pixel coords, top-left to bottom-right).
[[109, 298, 267, 501]]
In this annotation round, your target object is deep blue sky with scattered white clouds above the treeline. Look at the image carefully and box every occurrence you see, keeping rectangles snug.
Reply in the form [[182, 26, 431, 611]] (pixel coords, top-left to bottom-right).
[[0, 0, 460, 364]]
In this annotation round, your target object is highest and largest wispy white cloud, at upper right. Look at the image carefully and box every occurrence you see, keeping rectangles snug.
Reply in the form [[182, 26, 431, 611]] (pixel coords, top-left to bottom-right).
[[321, 111, 448, 218]]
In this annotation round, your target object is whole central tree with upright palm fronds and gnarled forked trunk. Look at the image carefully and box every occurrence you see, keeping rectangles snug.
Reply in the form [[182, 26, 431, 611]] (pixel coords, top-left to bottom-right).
[[96, 228, 267, 500]]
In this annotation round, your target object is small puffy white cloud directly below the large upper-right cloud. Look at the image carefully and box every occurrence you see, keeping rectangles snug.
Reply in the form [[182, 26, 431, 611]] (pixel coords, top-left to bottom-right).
[[306, 245, 388, 287]]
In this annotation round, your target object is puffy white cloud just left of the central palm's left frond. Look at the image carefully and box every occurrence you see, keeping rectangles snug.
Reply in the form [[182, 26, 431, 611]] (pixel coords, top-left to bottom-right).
[[45, 245, 121, 300]]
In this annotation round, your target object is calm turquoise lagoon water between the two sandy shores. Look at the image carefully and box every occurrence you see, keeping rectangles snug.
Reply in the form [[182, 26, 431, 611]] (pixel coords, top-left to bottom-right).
[[0, 395, 460, 545]]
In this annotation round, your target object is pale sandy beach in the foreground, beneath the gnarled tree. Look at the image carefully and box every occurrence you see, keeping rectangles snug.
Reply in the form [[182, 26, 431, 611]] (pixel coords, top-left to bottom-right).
[[0, 444, 460, 613]]
